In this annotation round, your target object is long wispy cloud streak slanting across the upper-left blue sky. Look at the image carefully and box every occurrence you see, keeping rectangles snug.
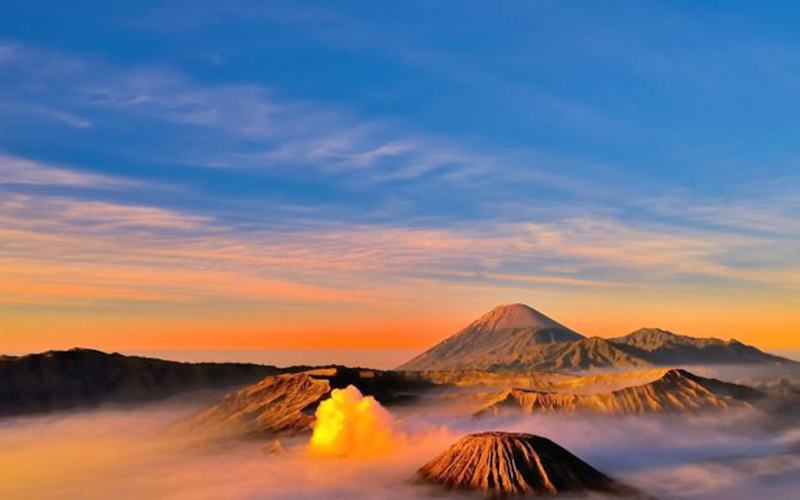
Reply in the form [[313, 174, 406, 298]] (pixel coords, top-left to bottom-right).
[[0, 41, 600, 197]]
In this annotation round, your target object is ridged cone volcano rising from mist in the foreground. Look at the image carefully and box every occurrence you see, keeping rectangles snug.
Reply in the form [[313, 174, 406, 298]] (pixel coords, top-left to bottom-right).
[[417, 432, 639, 496]]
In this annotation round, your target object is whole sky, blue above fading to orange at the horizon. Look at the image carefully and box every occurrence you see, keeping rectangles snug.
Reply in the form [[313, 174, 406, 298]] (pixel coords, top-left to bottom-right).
[[0, 0, 800, 352]]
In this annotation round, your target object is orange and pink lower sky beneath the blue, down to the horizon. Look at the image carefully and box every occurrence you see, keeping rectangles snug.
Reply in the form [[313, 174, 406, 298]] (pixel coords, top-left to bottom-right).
[[0, 186, 800, 352]]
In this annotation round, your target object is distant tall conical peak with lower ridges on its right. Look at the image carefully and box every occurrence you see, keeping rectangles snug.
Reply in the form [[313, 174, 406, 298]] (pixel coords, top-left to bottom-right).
[[398, 304, 800, 371]]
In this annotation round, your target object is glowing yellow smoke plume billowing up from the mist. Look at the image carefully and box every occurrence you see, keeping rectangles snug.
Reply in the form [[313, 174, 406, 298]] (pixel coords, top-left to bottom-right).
[[310, 385, 393, 456]]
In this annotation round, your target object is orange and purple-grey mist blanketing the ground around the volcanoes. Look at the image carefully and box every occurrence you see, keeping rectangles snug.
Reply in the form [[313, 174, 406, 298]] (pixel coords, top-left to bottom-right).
[[0, 403, 800, 500]]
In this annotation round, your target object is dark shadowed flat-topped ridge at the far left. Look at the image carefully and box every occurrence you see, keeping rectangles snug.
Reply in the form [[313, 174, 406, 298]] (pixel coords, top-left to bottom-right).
[[0, 349, 280, 416]]
